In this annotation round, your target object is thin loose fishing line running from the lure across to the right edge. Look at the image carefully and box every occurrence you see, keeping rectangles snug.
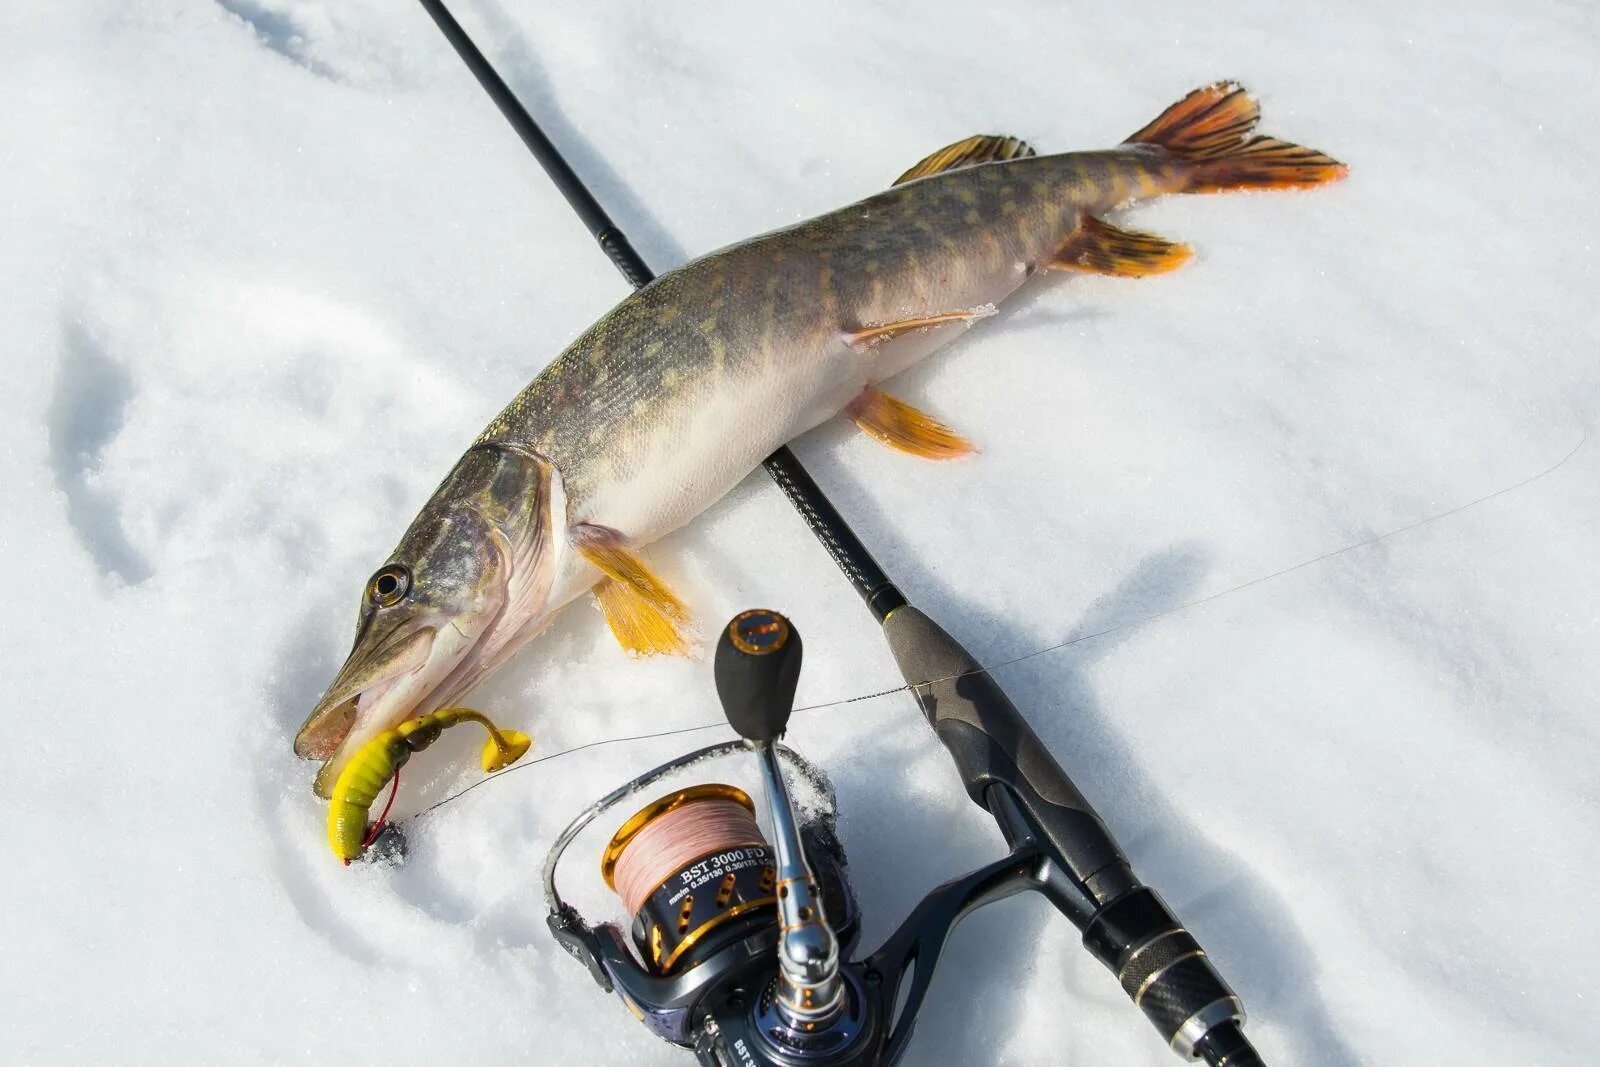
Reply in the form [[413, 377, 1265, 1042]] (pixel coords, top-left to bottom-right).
[[411, 426, 1589, 819]]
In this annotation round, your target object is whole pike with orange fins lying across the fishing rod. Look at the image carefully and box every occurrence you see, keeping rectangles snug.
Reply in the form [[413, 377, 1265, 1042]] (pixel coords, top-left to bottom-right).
[[294, 83, 1346, 797]]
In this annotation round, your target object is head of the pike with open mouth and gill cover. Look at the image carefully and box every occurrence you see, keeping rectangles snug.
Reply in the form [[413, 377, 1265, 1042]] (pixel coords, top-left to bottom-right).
[[294, 443, 566, 797]]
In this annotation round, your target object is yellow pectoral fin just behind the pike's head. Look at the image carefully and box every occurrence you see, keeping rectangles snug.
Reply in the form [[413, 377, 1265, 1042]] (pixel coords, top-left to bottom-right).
[[573, 523, 694, 656]]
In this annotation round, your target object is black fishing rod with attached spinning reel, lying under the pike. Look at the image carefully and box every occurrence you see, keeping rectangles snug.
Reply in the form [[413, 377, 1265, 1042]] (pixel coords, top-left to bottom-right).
[[419, 0, 1262, 1067]]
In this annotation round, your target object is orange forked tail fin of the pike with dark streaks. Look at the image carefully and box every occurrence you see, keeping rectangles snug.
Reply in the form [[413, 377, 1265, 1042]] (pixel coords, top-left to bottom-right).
[[1128, 82, 1347, 192]]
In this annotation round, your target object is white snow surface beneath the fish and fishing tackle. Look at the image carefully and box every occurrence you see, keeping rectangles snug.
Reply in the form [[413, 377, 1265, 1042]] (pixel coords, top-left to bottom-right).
[[0, 0, 1600, 1065]]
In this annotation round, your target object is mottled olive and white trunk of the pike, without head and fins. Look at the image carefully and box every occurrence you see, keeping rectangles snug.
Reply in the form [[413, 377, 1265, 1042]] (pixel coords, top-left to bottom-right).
[[478, 149, 1176, 563]]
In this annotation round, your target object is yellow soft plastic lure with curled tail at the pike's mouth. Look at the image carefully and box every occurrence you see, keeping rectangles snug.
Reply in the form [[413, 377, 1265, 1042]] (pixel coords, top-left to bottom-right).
[[328, 707, 533, 862]]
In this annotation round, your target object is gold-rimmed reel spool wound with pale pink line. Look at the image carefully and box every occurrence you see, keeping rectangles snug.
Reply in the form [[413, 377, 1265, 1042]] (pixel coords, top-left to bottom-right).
[[600, 782, 778, 976]]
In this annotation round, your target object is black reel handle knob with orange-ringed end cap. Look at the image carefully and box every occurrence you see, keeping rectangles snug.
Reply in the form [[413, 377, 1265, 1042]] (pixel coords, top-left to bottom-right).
[[712, 608, 800, 742]]
